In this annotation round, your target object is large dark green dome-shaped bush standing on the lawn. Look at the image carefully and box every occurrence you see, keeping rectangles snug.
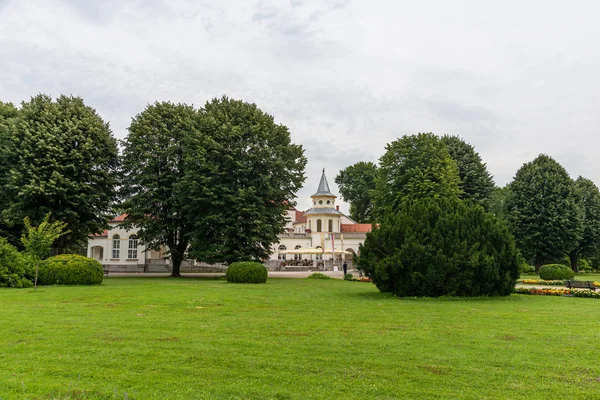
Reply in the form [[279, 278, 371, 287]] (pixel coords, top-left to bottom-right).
[[359, 198, 521, 297]]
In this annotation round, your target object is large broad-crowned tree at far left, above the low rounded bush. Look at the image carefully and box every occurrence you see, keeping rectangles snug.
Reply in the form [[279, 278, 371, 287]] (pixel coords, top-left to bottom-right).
[[1, 94, 118, 252]]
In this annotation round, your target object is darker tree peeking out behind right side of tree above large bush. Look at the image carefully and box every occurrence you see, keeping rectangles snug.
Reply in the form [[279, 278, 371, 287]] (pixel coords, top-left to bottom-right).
[[441, 135, 495, 209]]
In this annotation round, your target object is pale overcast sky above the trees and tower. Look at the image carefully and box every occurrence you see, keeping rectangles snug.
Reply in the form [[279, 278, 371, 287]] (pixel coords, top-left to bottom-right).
[[0, 0, 600, 210]]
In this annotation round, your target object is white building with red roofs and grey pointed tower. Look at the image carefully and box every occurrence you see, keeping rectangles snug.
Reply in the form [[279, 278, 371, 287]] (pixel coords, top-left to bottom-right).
[[87, 170, 371, 272]]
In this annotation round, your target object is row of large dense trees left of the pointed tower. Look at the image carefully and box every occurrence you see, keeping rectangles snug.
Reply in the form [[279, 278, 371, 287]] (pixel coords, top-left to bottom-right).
[[0, 94, 306, 276]]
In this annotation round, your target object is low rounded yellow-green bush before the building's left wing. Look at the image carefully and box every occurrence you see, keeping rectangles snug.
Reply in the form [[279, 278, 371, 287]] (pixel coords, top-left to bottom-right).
[[38, 254, 104, 285]]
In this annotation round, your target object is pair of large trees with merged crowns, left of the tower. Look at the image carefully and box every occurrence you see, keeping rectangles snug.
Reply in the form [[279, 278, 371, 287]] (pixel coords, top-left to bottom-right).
[[121, 97, 306, 276]]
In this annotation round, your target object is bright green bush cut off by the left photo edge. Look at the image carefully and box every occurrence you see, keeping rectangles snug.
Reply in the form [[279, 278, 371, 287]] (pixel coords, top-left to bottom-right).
[[0, 238, 35, 288]]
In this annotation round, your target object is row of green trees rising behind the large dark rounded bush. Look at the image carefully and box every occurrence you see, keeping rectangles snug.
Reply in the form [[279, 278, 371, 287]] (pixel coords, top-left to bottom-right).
[[336, 134, 600, 272]]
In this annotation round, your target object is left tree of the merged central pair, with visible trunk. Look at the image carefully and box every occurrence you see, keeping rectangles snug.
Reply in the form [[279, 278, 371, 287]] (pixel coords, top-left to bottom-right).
[[121, 102, 199, 276]]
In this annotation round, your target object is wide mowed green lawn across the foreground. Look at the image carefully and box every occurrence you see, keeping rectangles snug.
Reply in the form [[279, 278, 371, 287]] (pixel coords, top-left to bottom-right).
[[0, 278, 600, 399]]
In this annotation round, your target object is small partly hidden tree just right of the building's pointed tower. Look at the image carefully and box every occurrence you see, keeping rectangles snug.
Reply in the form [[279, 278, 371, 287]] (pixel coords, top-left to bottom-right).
[[335, 161, 377, 223]]
